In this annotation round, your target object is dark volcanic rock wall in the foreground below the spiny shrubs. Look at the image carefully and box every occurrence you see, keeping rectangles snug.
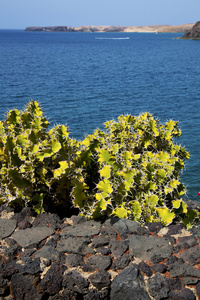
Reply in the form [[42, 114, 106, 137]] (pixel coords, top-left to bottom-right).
[[0, 207, 200, 300]]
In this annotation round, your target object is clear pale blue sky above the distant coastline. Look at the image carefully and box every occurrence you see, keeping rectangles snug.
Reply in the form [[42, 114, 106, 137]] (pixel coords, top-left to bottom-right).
[[0, 0, 200, 29]]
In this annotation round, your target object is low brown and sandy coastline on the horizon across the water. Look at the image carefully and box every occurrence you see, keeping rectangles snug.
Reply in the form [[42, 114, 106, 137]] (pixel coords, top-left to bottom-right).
[[25, 23, 195, 32]]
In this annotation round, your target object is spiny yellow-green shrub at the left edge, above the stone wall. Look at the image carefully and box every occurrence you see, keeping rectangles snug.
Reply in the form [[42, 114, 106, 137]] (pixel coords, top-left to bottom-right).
[[0, 101, 79, 214]]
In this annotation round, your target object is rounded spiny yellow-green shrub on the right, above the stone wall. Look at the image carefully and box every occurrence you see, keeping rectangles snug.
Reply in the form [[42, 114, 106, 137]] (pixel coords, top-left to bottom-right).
[[72, 113, 197, 224]]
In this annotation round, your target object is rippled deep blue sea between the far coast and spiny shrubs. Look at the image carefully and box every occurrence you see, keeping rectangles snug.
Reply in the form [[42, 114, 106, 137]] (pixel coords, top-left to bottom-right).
[[0, 30, 200, 200]]
